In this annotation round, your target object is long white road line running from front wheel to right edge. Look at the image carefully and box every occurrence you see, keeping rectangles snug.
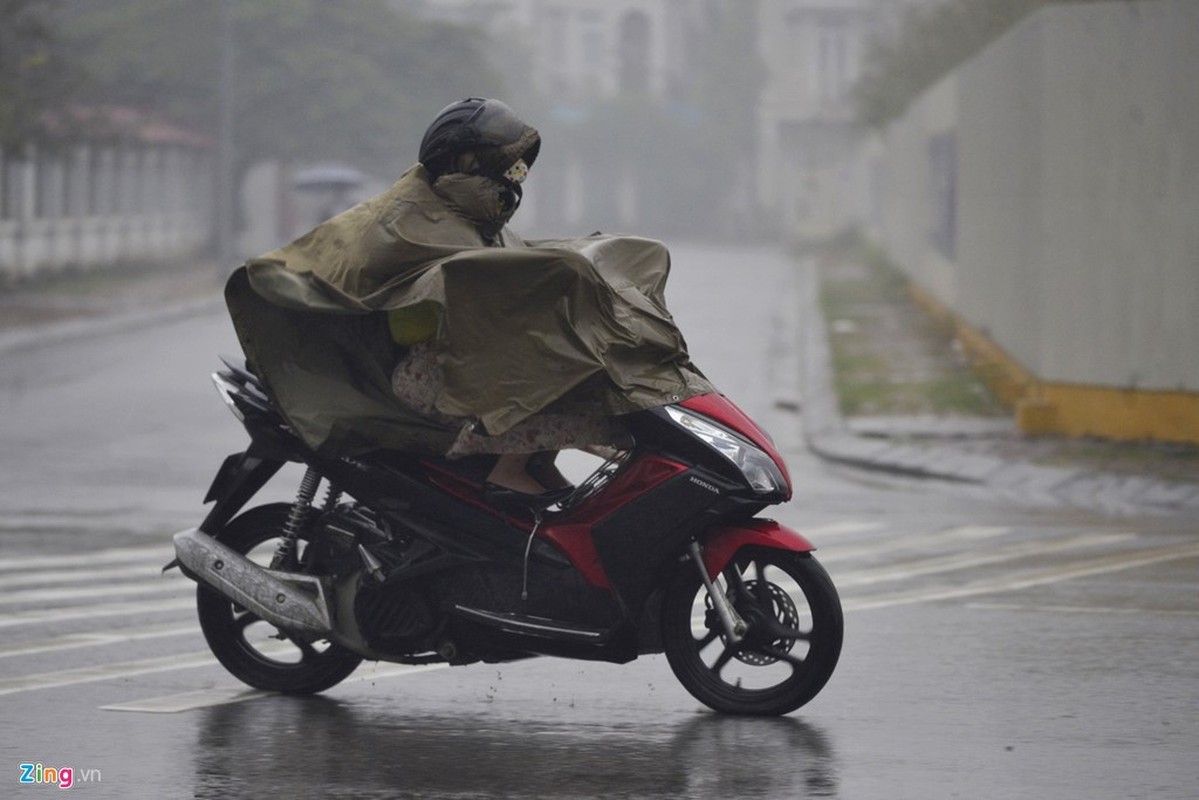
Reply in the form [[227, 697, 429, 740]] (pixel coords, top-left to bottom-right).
[[842, 545, 1199, 610]]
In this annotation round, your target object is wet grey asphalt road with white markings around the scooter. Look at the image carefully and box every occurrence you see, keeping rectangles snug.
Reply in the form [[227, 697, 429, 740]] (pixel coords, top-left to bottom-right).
[[0, 247, 1199, 799]]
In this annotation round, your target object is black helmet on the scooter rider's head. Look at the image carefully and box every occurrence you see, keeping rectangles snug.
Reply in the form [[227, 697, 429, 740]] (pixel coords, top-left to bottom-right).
[[420, 97, 541, 175]]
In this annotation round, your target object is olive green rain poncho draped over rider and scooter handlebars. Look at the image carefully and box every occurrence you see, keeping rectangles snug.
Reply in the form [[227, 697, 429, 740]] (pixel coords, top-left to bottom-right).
[[225, 164, 712, 456]]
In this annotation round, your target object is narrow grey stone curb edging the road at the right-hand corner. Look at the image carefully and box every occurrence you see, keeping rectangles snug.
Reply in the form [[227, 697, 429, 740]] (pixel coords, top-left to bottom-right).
[[791, 258, 1199, 516]]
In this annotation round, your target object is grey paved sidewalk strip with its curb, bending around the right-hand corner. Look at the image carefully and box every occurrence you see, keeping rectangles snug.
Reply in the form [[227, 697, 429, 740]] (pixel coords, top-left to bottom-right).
[[797, 258, 1199, 518]]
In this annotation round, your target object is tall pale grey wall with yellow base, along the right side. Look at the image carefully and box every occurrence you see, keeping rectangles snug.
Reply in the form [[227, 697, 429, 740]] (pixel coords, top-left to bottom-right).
[[873, 0, 1199, 392]]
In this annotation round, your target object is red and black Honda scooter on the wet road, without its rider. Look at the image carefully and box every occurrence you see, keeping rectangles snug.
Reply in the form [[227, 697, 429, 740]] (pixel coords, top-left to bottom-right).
[[164, 359, 843, 715]]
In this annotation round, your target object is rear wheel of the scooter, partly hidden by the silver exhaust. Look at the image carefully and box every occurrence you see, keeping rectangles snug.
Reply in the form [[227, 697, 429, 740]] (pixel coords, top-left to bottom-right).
[[195, 504, 362, 694]]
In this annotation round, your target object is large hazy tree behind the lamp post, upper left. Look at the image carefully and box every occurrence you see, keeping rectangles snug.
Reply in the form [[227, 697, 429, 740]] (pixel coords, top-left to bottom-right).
[[65, 0, 499, 173]]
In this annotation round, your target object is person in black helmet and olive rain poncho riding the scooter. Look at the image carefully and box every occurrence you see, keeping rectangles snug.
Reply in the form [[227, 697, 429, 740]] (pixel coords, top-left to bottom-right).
[[225, 97, 712, 501]]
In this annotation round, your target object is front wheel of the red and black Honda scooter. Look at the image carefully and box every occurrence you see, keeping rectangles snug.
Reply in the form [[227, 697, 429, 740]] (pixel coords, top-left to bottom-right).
[[662, 547, 844, 716]]
